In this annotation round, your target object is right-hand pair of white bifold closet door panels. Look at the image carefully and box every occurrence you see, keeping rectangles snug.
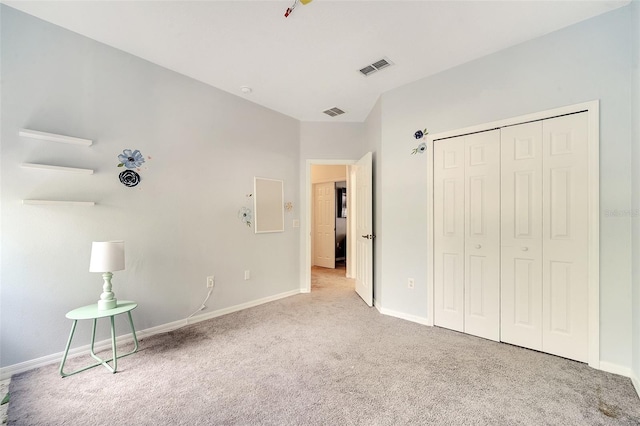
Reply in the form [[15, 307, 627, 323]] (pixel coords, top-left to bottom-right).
[[501, 113, 588, 362]]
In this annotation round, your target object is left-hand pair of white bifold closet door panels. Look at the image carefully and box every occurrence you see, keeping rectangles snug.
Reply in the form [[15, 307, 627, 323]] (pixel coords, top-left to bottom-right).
[[433, 130, 500, 340]]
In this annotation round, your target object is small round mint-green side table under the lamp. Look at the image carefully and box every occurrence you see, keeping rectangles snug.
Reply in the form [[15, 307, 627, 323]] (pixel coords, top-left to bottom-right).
[[59, 300, 138, 377]]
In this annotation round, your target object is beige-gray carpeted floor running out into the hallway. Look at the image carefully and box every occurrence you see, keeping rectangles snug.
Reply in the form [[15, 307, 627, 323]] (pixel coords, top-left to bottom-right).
[[8, 270, 640, 425]]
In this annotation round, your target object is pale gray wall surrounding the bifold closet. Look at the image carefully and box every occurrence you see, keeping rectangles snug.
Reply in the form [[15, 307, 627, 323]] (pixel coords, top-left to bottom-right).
[[376, 6, 638, 370]]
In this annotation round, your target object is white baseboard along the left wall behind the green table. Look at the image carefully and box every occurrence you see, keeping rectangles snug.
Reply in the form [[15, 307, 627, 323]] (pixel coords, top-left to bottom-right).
[[0, 289, 300, 380]]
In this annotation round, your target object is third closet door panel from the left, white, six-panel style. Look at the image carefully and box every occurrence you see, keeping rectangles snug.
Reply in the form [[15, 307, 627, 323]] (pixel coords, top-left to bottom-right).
[[500, 121, 542, 351]]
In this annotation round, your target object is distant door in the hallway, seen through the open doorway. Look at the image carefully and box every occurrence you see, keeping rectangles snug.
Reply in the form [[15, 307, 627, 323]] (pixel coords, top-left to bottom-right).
[[313, 182, 336, 269]]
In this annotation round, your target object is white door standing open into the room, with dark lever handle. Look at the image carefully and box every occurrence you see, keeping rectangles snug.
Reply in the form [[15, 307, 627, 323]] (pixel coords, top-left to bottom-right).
[[356, 152, 374, 306]]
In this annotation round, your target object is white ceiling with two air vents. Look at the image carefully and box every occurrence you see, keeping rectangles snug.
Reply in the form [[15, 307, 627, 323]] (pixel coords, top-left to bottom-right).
[[3, 0, 629, 122]]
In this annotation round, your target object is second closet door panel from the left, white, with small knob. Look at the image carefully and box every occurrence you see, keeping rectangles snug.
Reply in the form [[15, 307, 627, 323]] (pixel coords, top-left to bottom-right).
[[464, 130, 500, 341]]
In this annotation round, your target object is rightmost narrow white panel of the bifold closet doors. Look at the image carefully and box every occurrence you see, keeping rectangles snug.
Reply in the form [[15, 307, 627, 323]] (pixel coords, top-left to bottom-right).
[[542, 113, 589, 362]]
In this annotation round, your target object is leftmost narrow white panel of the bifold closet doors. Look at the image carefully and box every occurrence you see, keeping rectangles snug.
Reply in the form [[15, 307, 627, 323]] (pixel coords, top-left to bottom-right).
[[433, 137, 465, 331]]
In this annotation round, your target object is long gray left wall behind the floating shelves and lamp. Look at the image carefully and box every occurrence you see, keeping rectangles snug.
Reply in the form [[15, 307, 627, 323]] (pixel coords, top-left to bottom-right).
[[0, 5, 300, 366]]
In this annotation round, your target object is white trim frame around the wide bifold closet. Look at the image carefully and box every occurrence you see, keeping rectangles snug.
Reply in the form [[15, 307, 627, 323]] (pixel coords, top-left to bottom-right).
[[426, 100, 600, 369]]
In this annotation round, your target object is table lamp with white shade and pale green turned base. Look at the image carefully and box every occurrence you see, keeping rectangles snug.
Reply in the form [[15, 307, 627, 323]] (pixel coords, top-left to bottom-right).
[[89, 241, 124, 311]]
